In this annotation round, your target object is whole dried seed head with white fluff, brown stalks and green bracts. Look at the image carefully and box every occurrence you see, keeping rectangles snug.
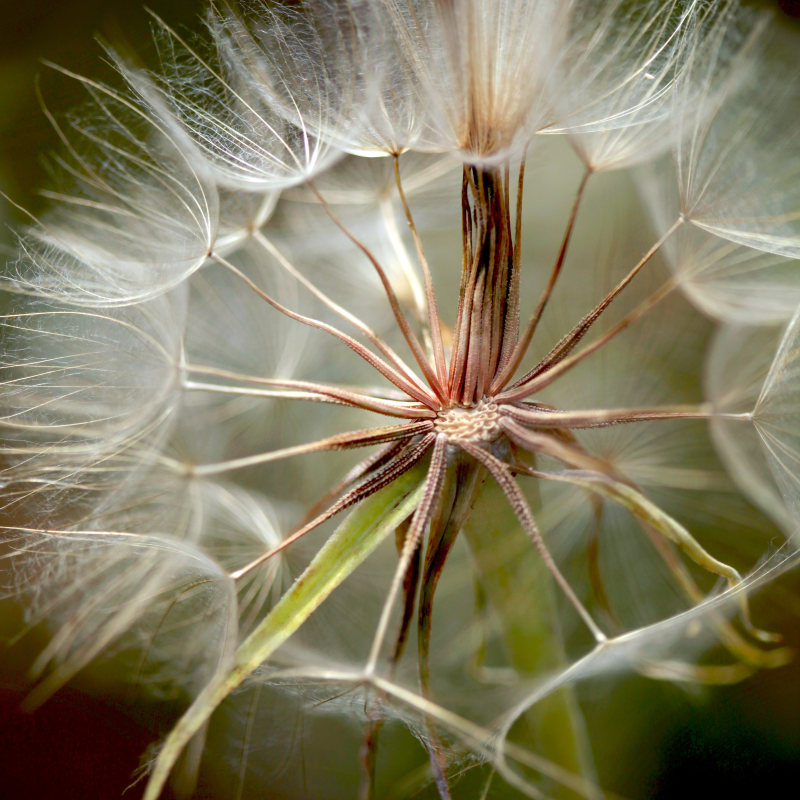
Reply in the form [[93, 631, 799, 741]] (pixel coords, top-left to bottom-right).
[[0, 0, 800, 800]]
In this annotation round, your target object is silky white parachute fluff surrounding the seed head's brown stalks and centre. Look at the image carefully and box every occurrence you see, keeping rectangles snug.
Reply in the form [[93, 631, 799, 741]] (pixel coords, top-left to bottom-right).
[[0, 0, 800, 796]]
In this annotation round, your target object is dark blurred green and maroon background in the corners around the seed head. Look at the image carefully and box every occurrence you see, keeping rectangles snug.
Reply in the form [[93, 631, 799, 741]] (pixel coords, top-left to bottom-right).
[[0, 0, 800, 800]]
